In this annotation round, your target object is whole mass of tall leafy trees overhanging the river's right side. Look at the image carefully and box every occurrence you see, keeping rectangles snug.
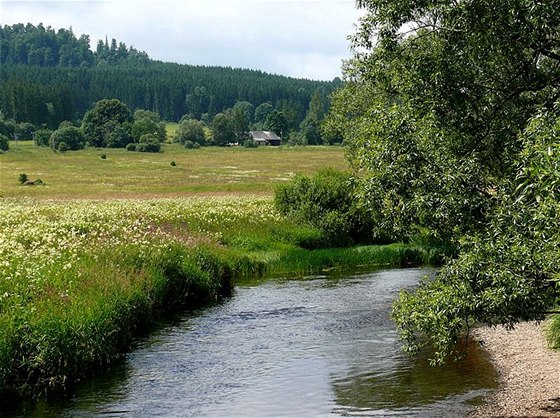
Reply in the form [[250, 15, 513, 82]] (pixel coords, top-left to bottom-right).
[[327, 0, 560, 361]]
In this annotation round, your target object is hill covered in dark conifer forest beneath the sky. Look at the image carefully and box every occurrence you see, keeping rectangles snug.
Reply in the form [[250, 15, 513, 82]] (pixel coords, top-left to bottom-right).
[[0, 24, 341, 128]]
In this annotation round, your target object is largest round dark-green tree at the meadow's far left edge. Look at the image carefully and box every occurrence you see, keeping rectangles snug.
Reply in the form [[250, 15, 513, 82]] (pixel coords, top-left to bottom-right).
[[82, 99, 132, 148]]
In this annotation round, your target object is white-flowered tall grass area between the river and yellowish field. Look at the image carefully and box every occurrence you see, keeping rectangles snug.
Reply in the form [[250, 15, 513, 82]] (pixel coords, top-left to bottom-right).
[[0, 196, 435, 396]]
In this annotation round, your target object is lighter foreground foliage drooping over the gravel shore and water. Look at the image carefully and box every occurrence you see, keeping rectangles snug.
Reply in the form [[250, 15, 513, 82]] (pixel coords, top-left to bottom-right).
[[393, 103, 560, 362]]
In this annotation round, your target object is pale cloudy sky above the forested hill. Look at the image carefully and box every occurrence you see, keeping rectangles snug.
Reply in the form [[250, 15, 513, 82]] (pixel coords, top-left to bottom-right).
[[0, 0, 361, 80]]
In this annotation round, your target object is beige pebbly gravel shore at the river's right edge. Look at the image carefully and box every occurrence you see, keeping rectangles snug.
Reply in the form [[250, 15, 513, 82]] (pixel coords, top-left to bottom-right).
[[469, 322, 560, 418]]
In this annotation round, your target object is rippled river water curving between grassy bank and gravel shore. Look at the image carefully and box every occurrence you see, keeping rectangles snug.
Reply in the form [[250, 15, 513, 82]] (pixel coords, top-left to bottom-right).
[[10, 269, 496, 417]]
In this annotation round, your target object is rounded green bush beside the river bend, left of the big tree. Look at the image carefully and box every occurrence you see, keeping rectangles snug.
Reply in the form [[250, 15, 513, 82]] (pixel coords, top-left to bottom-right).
[[274, 169, 386, 246]]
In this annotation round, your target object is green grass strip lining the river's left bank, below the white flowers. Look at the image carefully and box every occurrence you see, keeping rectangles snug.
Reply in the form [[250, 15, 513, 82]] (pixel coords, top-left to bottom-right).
[[0, 243, 438, 399]]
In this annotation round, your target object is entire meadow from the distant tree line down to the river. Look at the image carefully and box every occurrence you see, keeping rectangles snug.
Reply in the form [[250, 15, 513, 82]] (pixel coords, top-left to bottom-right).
[[0, 143, 437, 399]]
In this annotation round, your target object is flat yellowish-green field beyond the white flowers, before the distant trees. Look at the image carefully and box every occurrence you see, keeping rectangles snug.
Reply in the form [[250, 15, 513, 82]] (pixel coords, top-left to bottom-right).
[[0, 141, 348, 199]]
